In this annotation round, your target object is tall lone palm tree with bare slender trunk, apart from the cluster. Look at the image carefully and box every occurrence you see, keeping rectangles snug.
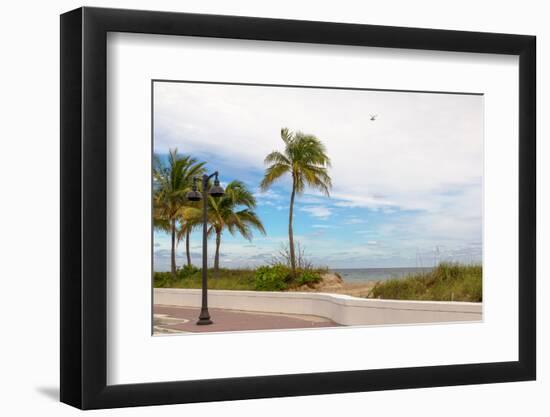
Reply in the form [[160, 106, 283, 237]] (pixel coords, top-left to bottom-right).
[[260, 128, 332, 275]]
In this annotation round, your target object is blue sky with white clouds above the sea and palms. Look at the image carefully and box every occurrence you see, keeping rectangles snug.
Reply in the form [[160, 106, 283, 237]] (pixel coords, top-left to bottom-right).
[[153, 82, 483, 270]]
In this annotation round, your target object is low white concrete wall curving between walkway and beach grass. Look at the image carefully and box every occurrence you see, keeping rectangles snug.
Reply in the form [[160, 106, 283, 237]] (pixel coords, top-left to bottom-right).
[[154, 288, 483, 326]]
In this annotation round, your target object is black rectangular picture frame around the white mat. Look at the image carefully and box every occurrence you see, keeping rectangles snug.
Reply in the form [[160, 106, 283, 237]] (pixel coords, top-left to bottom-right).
[[60, 7, 536, 409]]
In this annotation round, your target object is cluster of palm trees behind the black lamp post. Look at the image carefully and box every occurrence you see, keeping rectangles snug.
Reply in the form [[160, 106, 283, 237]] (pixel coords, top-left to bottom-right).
[[153, 149, 265, 275]]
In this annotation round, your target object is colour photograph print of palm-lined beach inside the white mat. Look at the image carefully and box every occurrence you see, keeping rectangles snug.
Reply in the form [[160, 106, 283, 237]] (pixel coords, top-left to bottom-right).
[[151, 80, 484, 335]]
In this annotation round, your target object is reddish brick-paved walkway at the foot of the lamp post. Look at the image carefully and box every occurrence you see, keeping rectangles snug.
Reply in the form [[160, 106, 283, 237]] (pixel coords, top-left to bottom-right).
[[154, 304, 339, 334]]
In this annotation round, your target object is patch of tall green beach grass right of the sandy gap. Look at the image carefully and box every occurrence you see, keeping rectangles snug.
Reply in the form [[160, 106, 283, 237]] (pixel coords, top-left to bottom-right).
[[368, 263, 483, 302]]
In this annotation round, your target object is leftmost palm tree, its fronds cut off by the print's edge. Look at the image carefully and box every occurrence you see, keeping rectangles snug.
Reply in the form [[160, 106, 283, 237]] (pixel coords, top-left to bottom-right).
[[153, 149, 204, 275]]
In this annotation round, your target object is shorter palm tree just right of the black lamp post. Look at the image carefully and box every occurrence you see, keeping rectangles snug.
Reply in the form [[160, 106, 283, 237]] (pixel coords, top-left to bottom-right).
[[188, 180, 265, 271]]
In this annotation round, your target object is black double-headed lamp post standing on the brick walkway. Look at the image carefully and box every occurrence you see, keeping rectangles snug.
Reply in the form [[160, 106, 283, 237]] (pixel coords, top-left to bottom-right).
[[187, 171, 224, 325]]
